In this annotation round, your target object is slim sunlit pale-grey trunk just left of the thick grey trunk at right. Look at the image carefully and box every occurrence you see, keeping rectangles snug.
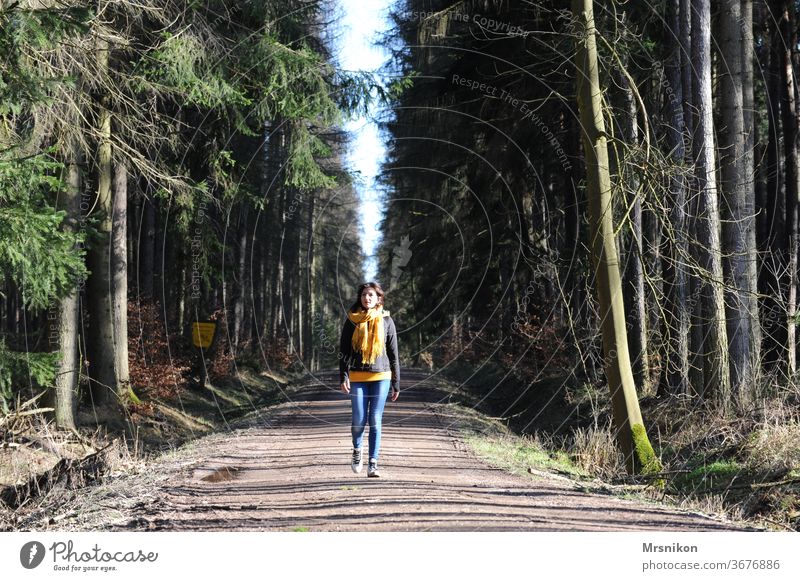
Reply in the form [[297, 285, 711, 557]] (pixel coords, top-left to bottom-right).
[[692, 0, 730, 406]]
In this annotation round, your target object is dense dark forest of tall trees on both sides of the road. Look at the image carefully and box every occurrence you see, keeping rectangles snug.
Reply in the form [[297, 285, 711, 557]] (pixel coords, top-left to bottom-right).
[[0, 0, 800, 514]]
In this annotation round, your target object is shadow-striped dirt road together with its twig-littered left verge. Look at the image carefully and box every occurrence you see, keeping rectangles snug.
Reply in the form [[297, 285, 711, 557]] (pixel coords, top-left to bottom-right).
[[0, 369, 757, 531]]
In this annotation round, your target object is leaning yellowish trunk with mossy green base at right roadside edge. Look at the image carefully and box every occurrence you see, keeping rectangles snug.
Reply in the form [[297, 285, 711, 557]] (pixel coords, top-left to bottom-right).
[[572, 0, 661, 473]]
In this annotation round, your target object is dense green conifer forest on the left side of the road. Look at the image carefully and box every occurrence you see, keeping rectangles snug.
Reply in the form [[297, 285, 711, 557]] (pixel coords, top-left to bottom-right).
[[0, 1, 370, 427]]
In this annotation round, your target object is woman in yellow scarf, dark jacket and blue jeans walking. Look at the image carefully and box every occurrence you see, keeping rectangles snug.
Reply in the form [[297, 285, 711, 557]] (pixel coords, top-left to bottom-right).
[[339, 282, 400, 477]]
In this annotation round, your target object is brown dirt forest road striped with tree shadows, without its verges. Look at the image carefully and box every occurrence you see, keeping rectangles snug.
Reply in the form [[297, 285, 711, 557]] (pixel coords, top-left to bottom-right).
[[69, 371, 752, 531]]
